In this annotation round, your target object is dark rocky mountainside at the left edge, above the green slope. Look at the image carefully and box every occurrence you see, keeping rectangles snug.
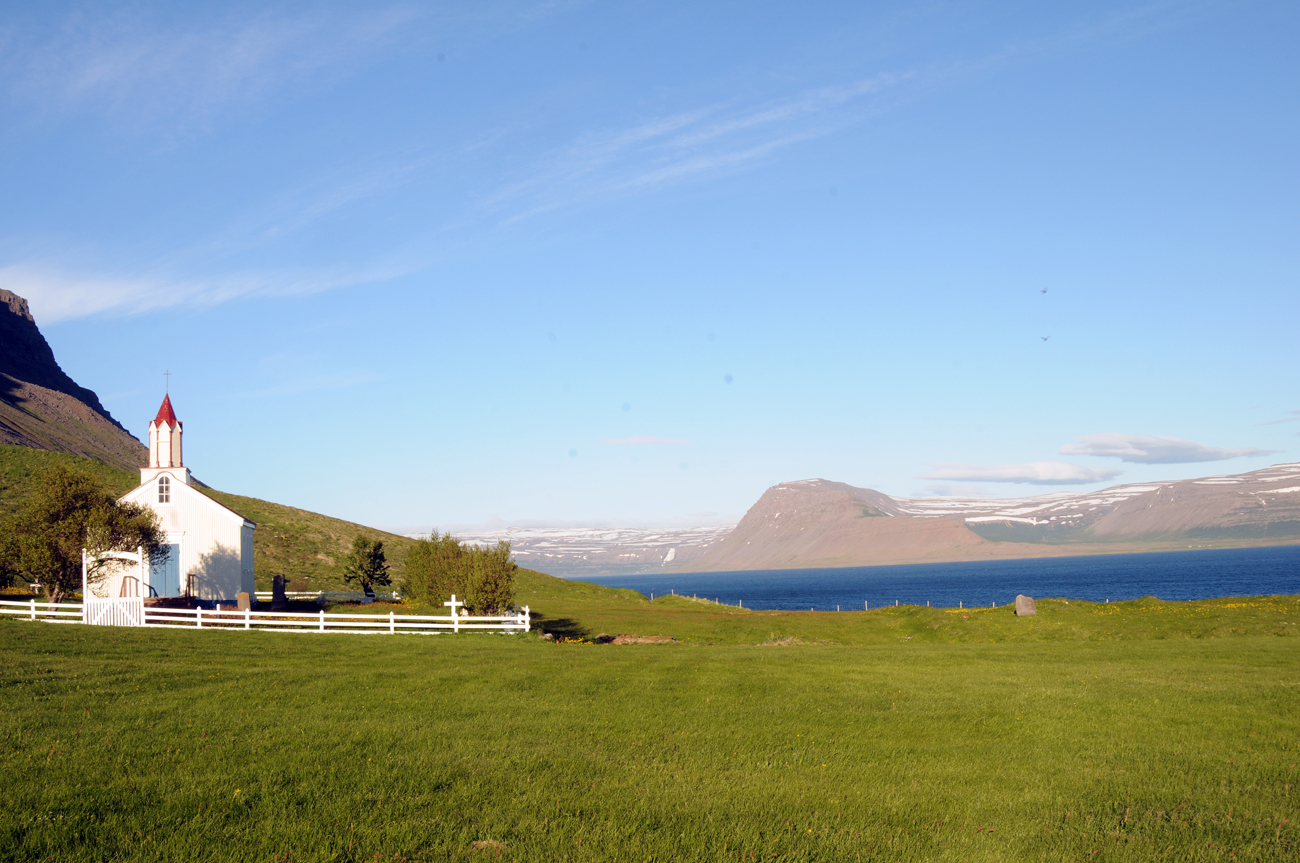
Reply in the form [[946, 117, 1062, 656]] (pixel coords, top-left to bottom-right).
[[0, 290, 148, 470]]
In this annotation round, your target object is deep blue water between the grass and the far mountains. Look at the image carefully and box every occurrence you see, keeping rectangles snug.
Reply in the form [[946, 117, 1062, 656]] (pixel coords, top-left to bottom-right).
[[576, 546, 1300, 611]]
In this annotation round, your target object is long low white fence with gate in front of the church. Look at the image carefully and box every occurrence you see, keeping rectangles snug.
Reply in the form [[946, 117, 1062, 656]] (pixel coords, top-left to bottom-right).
[[0, 598, 532, 634]]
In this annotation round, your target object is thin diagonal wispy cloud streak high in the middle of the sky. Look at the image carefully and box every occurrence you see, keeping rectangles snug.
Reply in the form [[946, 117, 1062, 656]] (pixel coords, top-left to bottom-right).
[[478, 73, 915, 221]]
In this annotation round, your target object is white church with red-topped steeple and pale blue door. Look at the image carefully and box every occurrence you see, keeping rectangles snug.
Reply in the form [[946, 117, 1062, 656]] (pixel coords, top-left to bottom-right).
[[91, 395, 257, 604]]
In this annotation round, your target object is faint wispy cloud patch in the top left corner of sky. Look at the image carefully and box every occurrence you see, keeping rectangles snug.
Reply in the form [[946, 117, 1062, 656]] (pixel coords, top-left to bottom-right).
[[0, 5, 425, 134]]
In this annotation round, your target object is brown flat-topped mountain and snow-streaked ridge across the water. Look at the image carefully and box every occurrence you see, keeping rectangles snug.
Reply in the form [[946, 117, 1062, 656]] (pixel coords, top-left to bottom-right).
[[671, 464, 1300, 572]]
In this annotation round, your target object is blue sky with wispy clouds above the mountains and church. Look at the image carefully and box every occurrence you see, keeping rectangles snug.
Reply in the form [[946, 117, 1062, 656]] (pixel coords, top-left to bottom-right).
[[0, 0, 1300, 528]]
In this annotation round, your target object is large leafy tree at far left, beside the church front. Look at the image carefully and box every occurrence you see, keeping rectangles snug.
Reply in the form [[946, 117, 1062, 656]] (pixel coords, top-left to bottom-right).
[[0, 465, 163, 602]]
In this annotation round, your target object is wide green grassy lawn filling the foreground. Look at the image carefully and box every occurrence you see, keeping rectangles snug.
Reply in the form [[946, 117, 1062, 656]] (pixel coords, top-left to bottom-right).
[[0, 592, 1300, 860]]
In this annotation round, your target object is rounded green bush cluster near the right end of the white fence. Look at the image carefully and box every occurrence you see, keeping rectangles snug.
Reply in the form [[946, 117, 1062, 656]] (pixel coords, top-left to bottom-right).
[[403, 530, 519, 615]]
